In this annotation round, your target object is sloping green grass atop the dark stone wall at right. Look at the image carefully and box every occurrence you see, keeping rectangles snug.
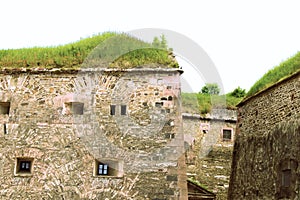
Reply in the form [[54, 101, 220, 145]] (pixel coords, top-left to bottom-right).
[[246, 52, 300, 97]]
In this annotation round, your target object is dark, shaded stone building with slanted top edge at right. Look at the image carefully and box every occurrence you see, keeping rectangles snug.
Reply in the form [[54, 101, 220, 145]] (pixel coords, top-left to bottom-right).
[[228, 68, 300, 199]]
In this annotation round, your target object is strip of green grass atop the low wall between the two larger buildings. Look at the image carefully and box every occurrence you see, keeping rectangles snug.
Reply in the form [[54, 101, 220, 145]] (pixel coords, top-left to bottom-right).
[[181, 93, 243, 115]]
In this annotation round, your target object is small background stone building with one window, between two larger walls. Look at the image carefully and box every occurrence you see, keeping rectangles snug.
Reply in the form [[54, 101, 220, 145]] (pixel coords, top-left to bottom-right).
[[183, 109, 236, 199]]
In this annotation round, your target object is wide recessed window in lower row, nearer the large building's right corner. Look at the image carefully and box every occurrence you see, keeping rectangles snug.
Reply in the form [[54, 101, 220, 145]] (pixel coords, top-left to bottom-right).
[[94, 160, 123, 177]]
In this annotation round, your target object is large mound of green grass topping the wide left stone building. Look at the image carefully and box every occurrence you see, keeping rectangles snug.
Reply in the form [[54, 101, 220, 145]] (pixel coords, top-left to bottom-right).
[[0, 32, 178, 69]]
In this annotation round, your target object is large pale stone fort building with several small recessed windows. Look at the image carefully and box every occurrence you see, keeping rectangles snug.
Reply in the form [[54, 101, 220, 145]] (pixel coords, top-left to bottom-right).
[[0, 66, 187, 200]]
